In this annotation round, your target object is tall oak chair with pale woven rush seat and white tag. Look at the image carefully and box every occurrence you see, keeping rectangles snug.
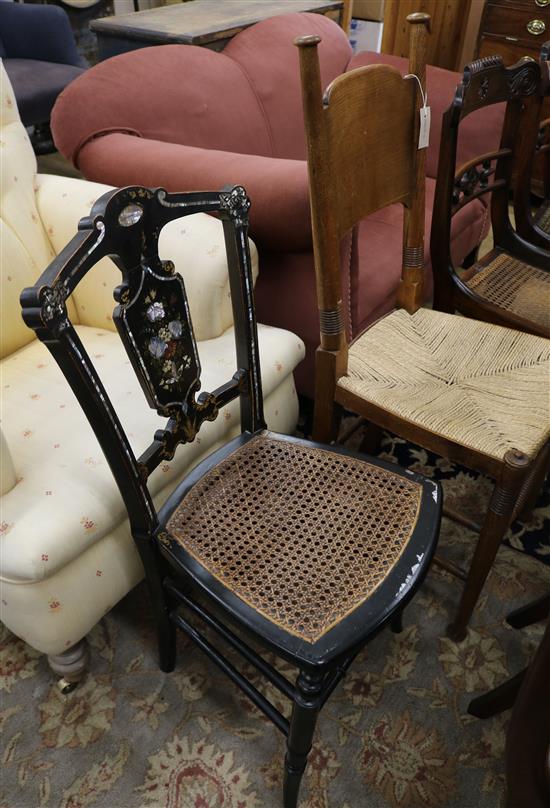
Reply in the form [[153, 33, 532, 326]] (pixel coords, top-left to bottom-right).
[[296, 13, 550, 639]]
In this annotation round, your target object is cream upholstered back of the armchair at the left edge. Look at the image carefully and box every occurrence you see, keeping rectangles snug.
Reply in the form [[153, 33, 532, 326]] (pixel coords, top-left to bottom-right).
[[0, 66, 54, 357]]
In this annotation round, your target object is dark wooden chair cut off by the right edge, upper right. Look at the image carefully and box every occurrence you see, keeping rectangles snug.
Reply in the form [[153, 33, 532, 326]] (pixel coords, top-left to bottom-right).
[[514, 42, 550, 251]]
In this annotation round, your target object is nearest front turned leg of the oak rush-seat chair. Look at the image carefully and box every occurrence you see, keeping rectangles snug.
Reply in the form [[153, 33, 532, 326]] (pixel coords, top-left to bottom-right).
[[447, 449, 530, 642]]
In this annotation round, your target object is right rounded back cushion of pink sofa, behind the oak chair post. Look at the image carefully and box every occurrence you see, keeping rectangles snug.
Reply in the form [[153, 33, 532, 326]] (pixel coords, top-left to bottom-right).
[[224, 14, 352, 160]]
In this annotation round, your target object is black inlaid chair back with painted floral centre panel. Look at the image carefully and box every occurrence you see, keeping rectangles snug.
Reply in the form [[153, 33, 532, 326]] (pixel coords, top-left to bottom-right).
[[21, 186, 265, 537]]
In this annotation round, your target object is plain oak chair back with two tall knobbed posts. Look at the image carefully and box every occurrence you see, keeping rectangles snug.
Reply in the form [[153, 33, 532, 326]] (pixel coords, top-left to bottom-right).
[[296, 14, 430, 368]]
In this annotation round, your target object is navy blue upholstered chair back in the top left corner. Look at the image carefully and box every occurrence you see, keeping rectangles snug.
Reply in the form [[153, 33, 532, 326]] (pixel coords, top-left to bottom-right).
[[0, 3, 87, 67]]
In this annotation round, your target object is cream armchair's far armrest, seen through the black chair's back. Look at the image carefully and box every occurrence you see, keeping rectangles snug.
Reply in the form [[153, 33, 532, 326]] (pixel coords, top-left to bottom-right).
[[36, 174, 258, 340]]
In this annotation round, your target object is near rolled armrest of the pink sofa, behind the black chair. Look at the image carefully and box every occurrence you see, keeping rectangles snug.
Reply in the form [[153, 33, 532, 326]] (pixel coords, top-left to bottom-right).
[[74, 132, 312, 252]]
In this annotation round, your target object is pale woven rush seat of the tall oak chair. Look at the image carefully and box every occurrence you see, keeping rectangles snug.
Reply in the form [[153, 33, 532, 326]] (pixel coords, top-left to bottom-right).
[[338, 309, 550, 460]]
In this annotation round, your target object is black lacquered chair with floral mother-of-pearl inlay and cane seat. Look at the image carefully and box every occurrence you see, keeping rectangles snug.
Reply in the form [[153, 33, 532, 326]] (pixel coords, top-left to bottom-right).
[[21, 187, 441, 808]]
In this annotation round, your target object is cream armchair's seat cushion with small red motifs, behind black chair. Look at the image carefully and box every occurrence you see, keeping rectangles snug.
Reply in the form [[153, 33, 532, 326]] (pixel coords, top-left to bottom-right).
[[2, 326, 304, 582]]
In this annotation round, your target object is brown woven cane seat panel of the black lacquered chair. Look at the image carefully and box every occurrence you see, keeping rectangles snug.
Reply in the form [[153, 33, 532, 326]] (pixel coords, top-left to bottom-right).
[[167, 433, 422, 643]]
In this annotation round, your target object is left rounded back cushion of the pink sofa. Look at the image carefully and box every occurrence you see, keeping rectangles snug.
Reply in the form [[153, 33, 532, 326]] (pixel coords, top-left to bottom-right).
[[52, 45, 271, 164]]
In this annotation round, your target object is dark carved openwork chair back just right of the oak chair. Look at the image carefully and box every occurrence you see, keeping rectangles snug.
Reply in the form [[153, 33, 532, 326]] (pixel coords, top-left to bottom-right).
[[431, 49, 541, 284]]
